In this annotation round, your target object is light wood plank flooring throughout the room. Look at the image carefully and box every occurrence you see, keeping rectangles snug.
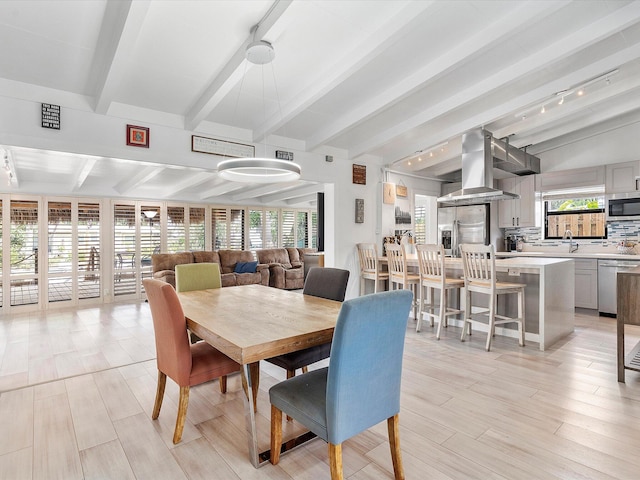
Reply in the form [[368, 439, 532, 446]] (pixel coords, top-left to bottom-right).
[[0, 302, 640, 480]]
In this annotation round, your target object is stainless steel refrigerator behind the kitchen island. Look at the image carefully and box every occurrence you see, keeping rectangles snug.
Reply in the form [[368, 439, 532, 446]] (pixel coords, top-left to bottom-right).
[[438, 203, 490, 257]]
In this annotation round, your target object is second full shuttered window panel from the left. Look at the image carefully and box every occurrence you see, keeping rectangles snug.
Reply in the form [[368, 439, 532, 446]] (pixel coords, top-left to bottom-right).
[[47, 202, 73, 302]]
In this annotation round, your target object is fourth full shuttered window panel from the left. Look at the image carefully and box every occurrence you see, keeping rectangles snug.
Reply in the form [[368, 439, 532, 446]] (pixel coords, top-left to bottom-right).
[[113, 205, 138, 296]]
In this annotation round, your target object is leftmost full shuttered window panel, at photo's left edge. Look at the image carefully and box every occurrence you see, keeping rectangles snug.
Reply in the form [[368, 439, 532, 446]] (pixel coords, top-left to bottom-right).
[[9, 200, 39, 305]]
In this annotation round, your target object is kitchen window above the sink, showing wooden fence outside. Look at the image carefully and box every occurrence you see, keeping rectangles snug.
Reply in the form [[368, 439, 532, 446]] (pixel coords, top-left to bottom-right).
[[542, 187, 607, 239]]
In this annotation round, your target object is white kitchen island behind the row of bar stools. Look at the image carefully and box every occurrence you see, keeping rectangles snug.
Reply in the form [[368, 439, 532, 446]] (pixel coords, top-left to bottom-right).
[[440, 257, 575, 350]]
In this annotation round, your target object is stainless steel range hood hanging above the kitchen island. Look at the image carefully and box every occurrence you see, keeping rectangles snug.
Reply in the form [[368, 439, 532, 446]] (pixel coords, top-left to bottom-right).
[[438, 128, 540, 205]]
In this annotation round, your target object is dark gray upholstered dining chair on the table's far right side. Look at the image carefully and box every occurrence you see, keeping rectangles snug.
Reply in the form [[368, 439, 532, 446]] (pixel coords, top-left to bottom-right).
[[267, 267, 349, 378]]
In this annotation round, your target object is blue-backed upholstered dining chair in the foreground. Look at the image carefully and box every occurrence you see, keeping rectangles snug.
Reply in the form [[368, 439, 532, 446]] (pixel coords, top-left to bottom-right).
[[269, 290, 413, 480]]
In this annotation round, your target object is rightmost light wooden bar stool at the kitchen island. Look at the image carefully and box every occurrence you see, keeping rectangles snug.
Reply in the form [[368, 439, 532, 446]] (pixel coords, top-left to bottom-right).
[[460, 244, 525, 352]]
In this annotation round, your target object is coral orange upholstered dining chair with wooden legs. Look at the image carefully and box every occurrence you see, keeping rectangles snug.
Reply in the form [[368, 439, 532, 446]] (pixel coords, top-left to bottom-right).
[[142, 278, 240, 443]]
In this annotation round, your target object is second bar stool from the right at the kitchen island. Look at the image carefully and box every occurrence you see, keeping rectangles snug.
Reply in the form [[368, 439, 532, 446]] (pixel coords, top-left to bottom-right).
[[416, 244, 464, 340]]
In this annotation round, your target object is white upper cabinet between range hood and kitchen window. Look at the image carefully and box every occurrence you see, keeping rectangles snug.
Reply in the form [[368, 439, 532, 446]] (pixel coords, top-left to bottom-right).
[[498, 175, 536, 228]]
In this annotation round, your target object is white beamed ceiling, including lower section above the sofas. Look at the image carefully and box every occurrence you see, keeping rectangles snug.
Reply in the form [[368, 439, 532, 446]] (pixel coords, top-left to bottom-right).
[[0, 0, 640, 205]]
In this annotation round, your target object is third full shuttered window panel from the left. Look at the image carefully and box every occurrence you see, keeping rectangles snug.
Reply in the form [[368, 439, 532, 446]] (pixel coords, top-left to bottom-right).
[[76, 202, 102, 299]]
